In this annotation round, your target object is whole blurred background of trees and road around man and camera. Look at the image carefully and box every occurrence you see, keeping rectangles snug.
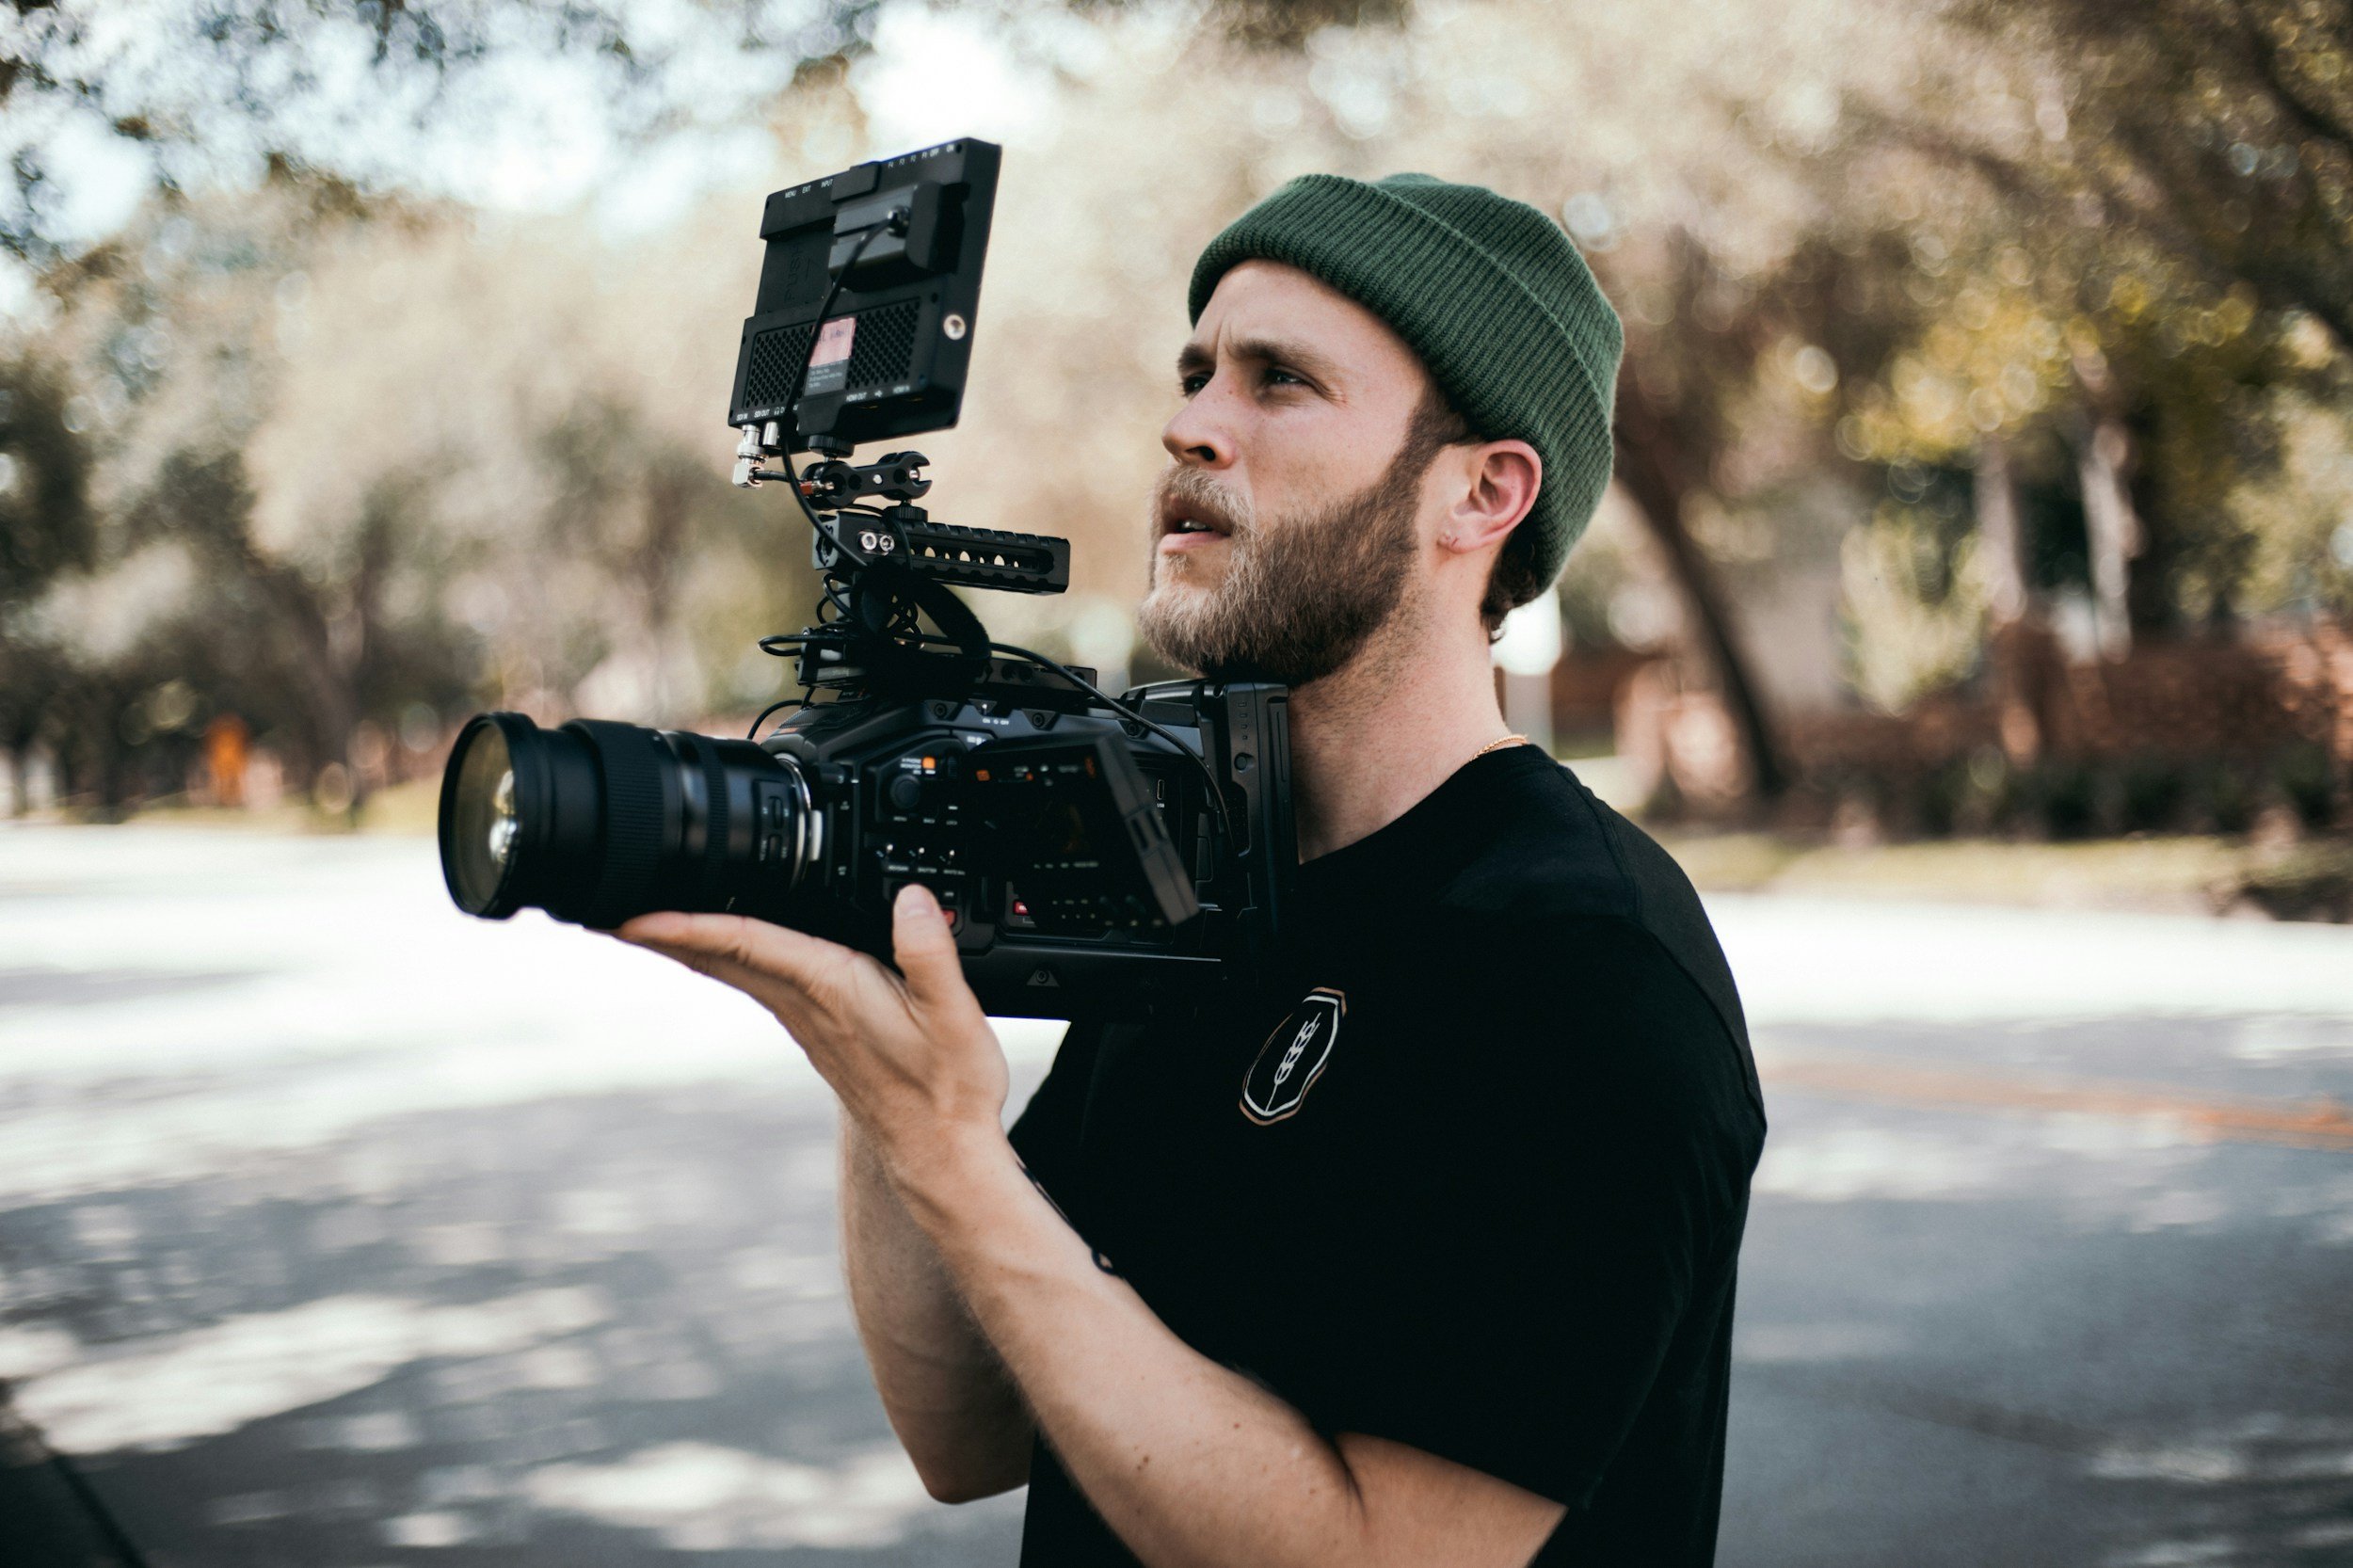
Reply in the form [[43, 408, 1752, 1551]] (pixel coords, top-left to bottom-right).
[[0, 0, 2353, 1565]]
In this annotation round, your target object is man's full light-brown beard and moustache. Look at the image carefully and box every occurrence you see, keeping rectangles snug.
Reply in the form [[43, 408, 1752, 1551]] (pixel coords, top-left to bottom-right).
[[1137, 440, 1435, 687]]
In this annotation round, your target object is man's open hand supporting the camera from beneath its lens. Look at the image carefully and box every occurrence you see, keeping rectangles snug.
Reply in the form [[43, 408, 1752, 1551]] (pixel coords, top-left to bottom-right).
[[615, 883, 1007, 1170]]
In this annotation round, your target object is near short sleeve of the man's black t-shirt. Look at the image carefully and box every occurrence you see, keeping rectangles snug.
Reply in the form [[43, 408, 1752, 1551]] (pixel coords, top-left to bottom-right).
[[1302, 919, 1763, 1509]]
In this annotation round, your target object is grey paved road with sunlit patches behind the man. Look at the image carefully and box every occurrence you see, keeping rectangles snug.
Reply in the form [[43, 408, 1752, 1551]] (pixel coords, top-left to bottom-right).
[[0, 829, 2353, 1568]]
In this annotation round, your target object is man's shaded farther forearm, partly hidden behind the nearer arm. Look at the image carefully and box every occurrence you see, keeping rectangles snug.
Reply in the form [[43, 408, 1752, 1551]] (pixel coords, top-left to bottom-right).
[[842, 1116, 1031, 1502]]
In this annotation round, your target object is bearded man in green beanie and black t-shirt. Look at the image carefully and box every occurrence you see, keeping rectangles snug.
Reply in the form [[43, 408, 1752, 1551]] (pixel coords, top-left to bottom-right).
[[621, 174, 1765, 1568]]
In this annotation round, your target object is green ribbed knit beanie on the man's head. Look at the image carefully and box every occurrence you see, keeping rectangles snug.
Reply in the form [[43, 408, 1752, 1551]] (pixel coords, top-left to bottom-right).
[[1191, 174, 1626, 593]]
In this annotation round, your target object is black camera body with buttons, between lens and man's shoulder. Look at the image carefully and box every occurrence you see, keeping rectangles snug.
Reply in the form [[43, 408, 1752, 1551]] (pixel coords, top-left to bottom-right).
[[762, 664, 1297, 1017]]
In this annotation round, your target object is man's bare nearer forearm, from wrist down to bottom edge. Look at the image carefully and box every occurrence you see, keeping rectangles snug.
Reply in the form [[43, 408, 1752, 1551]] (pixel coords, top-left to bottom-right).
[[906, 1140, 1384, 1568]]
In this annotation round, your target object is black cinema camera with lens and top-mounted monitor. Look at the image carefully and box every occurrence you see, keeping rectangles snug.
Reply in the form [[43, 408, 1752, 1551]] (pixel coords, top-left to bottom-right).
[[440, 139, 1297, 1019]]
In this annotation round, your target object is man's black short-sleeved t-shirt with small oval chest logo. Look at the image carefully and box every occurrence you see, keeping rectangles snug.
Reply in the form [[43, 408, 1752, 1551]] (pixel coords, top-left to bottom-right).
[[1015, 746, 1765, 1568]]
